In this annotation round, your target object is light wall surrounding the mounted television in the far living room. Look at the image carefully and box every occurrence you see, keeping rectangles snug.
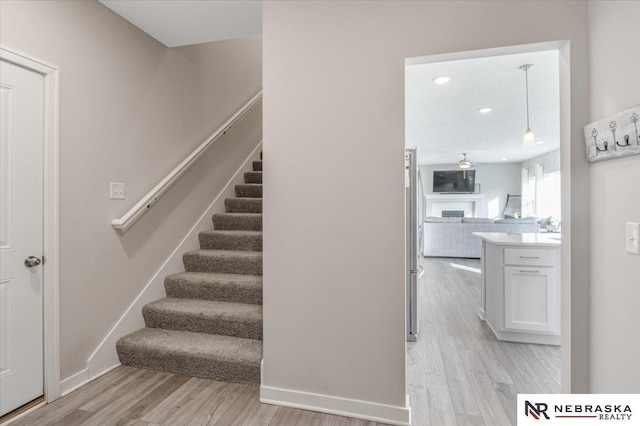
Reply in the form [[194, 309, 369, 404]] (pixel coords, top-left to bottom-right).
[[420, 163, 521, 219]]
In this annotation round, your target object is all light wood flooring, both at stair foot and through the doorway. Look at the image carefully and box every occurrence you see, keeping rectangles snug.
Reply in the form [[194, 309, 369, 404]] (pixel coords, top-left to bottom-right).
[[13, 255, 560, 426]]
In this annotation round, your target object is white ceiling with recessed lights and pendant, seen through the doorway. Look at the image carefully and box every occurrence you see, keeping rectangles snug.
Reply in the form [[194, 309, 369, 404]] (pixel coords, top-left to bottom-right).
[[405, 51, 560, 164]]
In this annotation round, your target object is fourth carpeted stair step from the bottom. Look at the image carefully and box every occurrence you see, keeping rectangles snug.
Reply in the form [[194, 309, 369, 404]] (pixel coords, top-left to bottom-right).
[[182, 250, 262, 275]]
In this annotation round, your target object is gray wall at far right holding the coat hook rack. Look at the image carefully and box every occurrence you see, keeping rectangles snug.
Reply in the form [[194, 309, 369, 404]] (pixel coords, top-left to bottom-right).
[[589, 1, 640, 393]]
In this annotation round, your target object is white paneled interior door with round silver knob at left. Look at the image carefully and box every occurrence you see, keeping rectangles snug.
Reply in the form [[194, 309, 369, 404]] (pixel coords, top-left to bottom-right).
[[0, 61, 44, 415]]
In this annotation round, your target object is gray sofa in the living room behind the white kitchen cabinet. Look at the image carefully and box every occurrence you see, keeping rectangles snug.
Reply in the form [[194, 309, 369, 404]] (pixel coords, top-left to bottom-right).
[[422, 217, 540, 258]]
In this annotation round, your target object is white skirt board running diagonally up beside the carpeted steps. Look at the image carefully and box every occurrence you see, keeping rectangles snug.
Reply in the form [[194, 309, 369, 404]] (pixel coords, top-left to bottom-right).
[[85, 142, 262, 378]]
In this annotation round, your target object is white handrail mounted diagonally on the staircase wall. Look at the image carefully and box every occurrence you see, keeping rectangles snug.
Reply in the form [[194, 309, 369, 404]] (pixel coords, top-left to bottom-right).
[[111, 90, 262, 234]]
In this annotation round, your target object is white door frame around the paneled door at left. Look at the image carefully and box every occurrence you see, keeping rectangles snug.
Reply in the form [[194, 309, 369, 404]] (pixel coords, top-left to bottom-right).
[[0, 46, 60, 402]]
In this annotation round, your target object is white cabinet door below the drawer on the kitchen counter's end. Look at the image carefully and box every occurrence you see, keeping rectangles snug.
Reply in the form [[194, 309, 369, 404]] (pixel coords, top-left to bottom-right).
[[504, 266, 558, 333]]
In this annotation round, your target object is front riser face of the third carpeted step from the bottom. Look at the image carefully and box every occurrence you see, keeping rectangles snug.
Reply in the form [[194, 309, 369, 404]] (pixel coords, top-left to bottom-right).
[[164, 278, 262, 305]]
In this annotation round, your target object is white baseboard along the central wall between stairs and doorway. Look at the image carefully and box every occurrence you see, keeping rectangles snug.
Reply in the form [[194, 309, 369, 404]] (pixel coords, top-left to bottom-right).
[[260, 386, 411, 426]]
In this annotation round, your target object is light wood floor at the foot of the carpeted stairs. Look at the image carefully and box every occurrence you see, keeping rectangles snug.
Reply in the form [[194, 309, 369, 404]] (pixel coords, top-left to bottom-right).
[[12, 367, 382, 426]]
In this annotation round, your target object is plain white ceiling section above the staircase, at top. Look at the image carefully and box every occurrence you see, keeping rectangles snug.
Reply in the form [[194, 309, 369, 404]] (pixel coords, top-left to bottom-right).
[[100, 0, 262, 47]]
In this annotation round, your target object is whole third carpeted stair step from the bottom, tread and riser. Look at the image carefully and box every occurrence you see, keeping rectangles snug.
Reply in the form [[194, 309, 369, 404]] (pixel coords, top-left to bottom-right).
[[164, 272, 262, 305]]
